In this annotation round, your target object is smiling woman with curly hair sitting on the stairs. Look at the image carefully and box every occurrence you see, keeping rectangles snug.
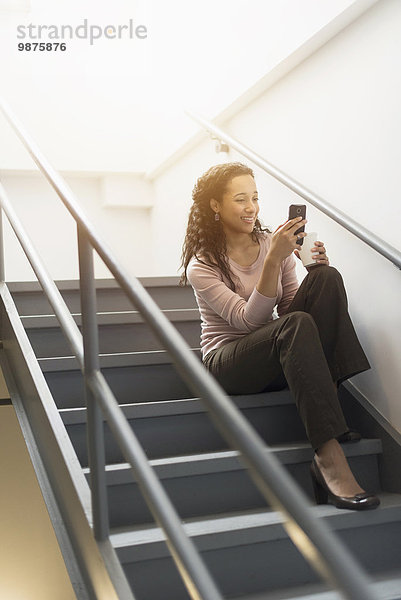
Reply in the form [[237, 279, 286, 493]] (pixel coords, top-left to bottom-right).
[[181, 163, 380, 510]]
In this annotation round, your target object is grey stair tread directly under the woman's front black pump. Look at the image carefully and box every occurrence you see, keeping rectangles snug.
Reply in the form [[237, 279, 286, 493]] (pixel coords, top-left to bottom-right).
[[111, 492, 401, 553]]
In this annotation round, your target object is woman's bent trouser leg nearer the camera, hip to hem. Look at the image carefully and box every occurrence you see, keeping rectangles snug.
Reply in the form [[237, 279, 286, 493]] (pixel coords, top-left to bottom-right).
[[205, 312, 348, 448]]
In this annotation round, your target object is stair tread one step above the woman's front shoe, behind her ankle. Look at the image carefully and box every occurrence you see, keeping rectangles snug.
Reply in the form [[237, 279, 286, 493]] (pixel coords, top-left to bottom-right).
[[80, 438, 382, 485]]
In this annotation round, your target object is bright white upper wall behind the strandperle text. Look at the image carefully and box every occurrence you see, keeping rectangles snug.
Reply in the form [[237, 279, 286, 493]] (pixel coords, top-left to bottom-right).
[[0, 0, 368, 172]]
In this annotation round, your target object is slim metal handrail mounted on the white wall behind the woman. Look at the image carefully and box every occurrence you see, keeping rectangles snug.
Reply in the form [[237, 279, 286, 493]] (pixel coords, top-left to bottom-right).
[[185, 110, 401, 269]]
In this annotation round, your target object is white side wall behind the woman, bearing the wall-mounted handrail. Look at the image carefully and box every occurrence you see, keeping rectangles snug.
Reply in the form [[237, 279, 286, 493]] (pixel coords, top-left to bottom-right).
[[149, 0, 401, 431]]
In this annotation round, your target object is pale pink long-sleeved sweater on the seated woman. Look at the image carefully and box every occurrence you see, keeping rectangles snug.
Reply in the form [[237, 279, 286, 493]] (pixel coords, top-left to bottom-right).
[[187, 233, 299, 358]]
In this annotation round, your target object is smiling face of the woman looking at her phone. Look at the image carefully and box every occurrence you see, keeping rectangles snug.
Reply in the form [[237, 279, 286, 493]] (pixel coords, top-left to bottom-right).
[[210, 175, 259, 233]]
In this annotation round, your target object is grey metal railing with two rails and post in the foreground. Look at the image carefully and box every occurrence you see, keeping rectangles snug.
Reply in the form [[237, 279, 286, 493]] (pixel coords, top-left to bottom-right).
[[0, 102, 376, 600]]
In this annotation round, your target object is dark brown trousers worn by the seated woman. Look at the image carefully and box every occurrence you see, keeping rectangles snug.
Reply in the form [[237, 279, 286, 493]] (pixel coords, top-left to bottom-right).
[[203, 265, 370, 449]]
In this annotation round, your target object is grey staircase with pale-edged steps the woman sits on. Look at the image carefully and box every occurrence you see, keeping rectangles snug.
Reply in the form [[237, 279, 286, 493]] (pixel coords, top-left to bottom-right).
[[9, 278, 401, 600]]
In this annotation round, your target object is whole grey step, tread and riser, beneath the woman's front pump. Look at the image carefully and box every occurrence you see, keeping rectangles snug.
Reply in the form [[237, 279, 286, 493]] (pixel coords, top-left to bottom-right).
[[111, 494, 401, 600]]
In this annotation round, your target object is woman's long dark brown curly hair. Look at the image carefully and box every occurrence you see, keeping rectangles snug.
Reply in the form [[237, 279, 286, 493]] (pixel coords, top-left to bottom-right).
[[180, 162, 268, 290]]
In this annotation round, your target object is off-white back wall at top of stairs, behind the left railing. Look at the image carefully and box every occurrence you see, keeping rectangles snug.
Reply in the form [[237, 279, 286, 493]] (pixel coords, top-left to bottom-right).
[[1, 174, 152, 281]]
